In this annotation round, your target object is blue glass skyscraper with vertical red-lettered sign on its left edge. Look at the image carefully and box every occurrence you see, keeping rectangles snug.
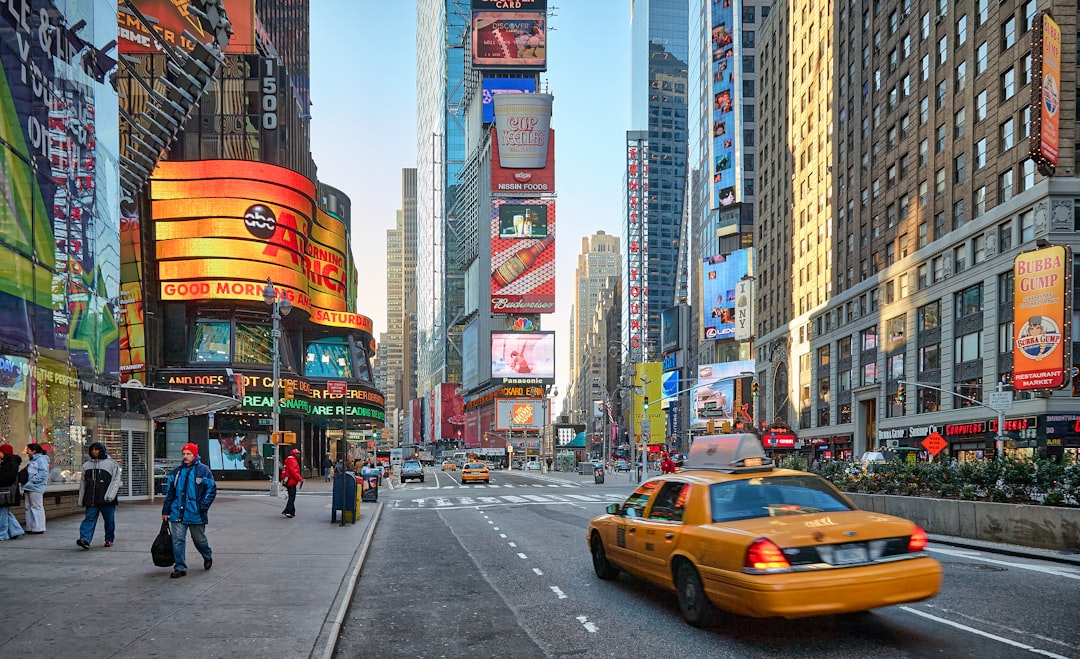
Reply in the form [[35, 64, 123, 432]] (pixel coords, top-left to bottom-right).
[[623, 0, 689, 362]]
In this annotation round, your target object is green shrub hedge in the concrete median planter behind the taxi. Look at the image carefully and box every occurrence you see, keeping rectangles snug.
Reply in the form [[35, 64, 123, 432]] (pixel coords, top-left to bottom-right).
[[781, 456, 1080, 507]]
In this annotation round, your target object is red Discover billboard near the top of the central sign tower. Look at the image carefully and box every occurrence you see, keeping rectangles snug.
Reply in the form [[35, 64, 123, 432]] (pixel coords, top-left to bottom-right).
[[472, 11, 548, 71]]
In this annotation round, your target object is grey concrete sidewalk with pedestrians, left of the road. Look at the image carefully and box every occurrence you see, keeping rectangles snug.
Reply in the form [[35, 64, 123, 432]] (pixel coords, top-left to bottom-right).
[[0, 479, 382, 658]]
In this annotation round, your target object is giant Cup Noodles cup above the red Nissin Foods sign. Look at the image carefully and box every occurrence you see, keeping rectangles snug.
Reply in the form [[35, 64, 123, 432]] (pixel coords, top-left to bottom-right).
[[491, 94, 555, 170]]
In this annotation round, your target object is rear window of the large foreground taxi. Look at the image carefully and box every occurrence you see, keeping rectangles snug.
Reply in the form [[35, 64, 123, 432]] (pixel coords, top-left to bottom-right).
[[708, 475, 852, 523]]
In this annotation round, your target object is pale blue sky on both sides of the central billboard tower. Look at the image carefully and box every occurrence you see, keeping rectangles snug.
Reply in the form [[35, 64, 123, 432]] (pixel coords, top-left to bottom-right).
[[311, 0, 630, 397]]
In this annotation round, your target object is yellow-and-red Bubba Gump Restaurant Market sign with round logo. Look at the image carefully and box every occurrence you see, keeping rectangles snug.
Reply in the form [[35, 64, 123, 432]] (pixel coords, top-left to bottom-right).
[[1013, 245, 1072, 391]]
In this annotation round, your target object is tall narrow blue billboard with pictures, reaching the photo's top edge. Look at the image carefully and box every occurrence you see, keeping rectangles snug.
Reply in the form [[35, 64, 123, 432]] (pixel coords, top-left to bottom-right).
[[711, 2, 739, 209]]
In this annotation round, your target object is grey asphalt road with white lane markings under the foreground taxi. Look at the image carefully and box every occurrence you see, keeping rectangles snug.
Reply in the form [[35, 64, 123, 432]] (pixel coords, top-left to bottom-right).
[[337, 469, 1080, 659]]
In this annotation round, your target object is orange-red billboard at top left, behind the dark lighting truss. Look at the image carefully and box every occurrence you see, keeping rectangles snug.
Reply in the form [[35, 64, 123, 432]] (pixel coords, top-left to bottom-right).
[[117, 0, 256, 55]]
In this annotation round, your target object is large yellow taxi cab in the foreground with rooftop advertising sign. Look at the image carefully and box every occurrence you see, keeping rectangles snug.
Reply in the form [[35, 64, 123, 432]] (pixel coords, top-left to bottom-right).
[[586, 433, 942, 627]]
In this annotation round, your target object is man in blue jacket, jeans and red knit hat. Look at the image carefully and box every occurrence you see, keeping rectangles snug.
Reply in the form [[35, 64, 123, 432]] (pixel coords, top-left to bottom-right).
[[161, 443, 217, 579]]
